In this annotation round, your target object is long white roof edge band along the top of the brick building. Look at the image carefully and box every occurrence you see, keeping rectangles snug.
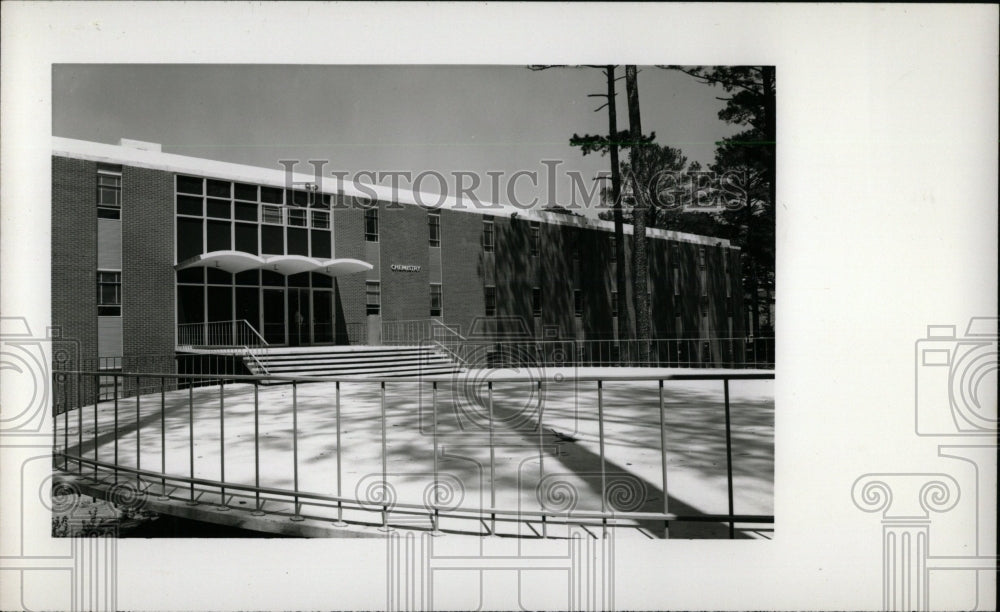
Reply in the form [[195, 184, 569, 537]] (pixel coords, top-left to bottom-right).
[[52, 136, 739, 250]]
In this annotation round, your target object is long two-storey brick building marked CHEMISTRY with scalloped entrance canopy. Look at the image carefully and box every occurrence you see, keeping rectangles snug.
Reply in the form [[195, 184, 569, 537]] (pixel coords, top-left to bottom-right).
[[52, 138, 745, 368]]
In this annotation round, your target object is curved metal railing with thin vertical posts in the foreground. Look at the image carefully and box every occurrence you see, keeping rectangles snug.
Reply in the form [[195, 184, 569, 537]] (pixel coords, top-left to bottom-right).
[[52, 370, 774, 538]]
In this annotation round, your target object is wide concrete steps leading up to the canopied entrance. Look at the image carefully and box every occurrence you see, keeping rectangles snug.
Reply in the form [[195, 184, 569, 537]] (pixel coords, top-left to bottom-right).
[[244, 346, 463, 377]]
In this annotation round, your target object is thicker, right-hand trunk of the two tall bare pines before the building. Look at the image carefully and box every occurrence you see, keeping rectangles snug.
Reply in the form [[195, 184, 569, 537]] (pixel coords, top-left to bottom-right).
[[625, 65, 650, 364]]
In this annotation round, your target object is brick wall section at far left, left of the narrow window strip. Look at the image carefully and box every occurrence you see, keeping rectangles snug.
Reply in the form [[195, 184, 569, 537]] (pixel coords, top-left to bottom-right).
[[52, 157, 97, 367]]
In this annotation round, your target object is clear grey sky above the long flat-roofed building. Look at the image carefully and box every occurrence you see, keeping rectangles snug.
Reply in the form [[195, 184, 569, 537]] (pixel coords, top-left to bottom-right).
[[52, 64, 741, 216]]
